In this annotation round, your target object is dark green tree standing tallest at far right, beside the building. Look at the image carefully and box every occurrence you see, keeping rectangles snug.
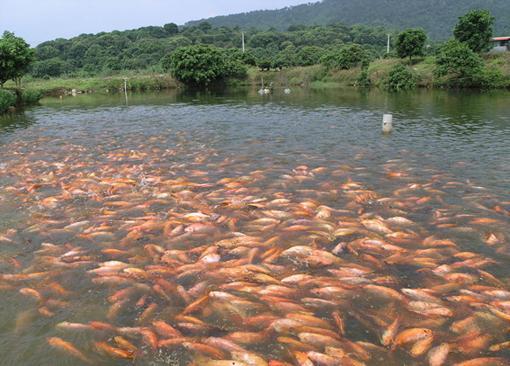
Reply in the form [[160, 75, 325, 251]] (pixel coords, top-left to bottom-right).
[[453, 10, 494, 53]]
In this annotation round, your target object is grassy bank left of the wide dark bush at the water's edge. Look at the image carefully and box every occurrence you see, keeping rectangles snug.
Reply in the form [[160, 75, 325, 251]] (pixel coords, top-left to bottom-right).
[[7, 74, 178, 96]]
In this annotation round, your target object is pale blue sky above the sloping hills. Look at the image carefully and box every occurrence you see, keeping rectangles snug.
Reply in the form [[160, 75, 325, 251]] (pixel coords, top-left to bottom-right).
[[0, 0, 307, 46]]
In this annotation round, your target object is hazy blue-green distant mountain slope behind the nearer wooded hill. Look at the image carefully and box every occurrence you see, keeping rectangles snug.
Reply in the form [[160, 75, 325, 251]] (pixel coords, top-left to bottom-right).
[[186, 0, 510, 39]]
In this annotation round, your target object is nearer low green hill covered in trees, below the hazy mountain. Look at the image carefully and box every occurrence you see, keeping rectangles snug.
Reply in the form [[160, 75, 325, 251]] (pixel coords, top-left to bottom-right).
[[32, 23, 386, 77]]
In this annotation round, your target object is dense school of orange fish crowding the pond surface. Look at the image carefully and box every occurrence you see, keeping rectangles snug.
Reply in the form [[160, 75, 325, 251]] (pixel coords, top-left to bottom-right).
[[0, 129, 510, 366]]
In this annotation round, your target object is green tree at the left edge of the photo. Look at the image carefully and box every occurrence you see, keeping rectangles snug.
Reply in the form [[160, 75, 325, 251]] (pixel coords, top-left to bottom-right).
[[0, 32, 35, 86]]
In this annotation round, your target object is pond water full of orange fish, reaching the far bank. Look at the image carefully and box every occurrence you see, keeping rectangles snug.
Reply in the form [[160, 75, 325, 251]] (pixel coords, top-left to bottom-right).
[[0, 89, 510, 366]]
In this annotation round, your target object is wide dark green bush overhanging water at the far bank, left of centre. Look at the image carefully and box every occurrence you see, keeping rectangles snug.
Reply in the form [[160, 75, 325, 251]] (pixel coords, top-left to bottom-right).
[[169, 45, 246, 86]]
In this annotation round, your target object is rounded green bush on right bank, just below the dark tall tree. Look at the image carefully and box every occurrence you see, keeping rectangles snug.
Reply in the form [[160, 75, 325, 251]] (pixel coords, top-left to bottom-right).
[[435, 39, 484, 87]]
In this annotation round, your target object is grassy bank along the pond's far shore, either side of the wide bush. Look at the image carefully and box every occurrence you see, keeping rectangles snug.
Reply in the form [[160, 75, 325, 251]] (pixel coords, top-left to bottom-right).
[[6, 53, 510, 100]]
